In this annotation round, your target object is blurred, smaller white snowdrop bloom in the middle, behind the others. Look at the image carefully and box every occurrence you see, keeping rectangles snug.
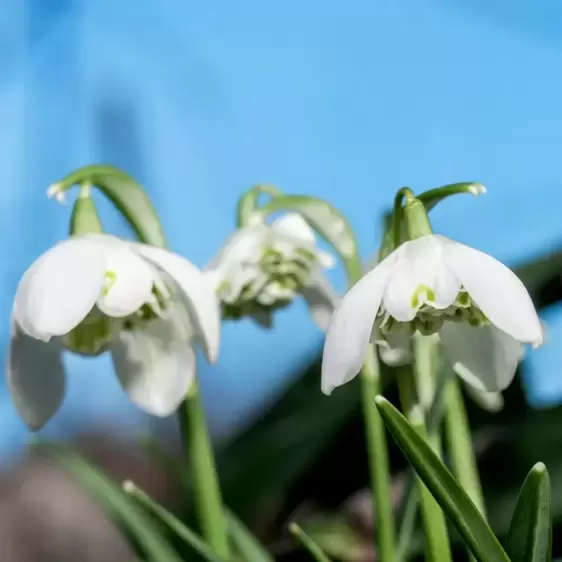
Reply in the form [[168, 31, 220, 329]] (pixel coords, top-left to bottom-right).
[[205, 213, 337, 330]]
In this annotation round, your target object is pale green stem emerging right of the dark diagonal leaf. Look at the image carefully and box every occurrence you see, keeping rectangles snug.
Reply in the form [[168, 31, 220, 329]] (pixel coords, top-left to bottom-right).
[[445, 376, 486, 560]]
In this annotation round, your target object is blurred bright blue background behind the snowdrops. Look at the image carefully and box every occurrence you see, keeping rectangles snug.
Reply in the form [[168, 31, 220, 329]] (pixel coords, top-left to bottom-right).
[[0, 0, 562, 454]]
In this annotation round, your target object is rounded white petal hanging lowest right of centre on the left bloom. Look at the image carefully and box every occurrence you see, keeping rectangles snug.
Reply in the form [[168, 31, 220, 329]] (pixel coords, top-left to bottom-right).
[[110, 317, 195, 417]]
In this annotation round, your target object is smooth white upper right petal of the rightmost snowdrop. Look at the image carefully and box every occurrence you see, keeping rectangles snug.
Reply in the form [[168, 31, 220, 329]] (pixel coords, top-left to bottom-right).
[[442, 234, 543, 346]]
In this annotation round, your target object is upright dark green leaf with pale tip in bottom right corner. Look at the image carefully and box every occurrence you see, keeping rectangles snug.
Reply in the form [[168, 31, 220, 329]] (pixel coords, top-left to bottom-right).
[[505, 463, 552, 562]]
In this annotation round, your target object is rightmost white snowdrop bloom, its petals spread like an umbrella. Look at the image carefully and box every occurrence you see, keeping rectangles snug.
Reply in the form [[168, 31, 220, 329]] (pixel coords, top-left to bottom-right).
[[322, 235, 543, 394]]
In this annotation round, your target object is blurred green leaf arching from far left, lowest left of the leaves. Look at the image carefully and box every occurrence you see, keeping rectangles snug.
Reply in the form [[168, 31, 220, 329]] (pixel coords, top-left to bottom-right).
[[34, 444, 181, 562]]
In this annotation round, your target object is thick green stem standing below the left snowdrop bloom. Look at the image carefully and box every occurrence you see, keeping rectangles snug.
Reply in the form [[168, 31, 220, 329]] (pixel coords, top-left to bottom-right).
[[178, 382, 230, 559]]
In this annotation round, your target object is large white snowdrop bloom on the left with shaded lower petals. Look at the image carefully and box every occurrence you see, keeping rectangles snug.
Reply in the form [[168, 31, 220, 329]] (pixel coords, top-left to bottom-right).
[[7, 234, 220, 430]]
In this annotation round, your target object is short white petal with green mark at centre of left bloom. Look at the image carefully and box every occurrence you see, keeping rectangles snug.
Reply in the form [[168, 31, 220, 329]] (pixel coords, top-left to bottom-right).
[[97, 243, 154, 318]]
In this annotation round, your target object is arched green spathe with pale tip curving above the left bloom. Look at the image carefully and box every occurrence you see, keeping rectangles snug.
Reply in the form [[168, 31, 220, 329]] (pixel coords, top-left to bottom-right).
[[49, 164, 166, 247]]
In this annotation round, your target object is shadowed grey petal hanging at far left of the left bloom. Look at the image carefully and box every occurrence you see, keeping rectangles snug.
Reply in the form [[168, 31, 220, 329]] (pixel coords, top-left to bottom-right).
[[6, 322, 65, 431]]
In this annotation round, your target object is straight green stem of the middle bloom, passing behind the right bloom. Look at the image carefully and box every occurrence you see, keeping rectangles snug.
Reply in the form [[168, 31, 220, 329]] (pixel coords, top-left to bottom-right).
[[346, 255, 398, 562]]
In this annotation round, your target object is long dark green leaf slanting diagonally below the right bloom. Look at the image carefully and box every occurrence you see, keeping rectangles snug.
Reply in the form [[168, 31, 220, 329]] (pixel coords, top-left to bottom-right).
[[376, 396, 509, 562]]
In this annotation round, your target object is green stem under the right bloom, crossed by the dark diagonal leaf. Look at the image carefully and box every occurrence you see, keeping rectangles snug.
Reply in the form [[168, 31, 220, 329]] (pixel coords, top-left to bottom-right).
[[398, 366, 452, 562]]
